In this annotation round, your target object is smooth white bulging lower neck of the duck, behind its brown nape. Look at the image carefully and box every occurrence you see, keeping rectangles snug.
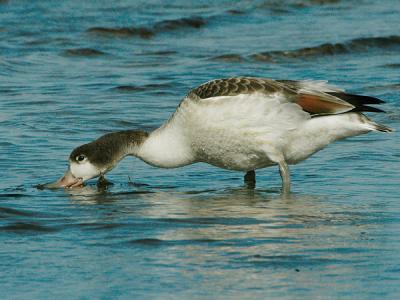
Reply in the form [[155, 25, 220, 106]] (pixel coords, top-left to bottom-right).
[[131, 124, 195, 168]]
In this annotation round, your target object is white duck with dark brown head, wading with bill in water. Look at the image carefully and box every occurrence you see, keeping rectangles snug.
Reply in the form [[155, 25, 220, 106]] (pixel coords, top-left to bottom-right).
[[48, 77, 393, 193]]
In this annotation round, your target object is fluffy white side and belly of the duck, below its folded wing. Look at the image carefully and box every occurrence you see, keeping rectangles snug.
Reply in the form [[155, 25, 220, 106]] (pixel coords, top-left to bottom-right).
[[174, 95, 309, 171]]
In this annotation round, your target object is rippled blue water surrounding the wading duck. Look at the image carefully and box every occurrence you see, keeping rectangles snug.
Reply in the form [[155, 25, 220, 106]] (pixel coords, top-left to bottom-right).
[[0, 0, 400, 299]]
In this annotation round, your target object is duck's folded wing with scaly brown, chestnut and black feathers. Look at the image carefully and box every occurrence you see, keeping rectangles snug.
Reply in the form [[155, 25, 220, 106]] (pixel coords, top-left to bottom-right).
[[188, 77, 383, 115]]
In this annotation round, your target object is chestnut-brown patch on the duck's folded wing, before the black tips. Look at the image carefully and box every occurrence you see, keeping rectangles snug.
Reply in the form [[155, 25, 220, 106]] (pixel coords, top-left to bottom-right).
[[296, 94, 354, 114]]
